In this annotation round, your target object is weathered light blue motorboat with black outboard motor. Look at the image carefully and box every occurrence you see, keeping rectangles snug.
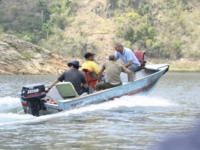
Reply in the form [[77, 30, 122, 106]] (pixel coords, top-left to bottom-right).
[[18, 64, 170, 116]]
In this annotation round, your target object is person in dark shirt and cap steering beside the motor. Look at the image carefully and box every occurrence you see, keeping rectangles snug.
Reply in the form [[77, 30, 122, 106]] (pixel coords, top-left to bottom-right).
[[47, 61, 89, 95]]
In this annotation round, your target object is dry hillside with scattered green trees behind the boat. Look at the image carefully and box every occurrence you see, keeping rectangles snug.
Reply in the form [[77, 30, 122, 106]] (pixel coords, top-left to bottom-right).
[[0, 0, 200, 60]]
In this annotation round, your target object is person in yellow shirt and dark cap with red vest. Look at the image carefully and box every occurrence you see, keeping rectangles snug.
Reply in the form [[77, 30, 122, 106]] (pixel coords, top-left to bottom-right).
[[81, 52, 99, 89]]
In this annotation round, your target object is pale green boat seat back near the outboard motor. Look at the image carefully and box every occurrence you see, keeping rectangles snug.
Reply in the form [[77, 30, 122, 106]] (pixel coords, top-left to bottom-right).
[[55, 82, 79, 99]]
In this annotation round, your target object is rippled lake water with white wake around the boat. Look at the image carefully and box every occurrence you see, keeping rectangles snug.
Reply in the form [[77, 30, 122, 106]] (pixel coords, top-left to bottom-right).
[[0, 73, 200, 150]]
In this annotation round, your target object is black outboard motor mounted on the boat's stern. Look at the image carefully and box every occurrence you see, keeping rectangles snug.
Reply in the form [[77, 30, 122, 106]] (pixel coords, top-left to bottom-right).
[[21, 84, 46, 116]]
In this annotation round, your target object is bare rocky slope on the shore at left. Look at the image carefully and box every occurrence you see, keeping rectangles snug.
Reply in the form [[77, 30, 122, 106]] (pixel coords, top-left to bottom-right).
[[0, 34, 67, 75]]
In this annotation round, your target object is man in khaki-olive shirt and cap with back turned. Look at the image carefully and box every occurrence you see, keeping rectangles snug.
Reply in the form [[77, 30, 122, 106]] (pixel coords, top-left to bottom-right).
[[95, 55, 134, 91]]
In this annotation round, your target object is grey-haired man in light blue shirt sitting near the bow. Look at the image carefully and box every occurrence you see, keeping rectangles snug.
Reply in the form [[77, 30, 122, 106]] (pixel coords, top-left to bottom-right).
[[115, 42, 141, 81]]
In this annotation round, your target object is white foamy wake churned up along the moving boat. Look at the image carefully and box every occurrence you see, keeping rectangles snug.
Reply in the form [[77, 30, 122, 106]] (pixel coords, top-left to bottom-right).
[[0, 96, 176, 126]]
